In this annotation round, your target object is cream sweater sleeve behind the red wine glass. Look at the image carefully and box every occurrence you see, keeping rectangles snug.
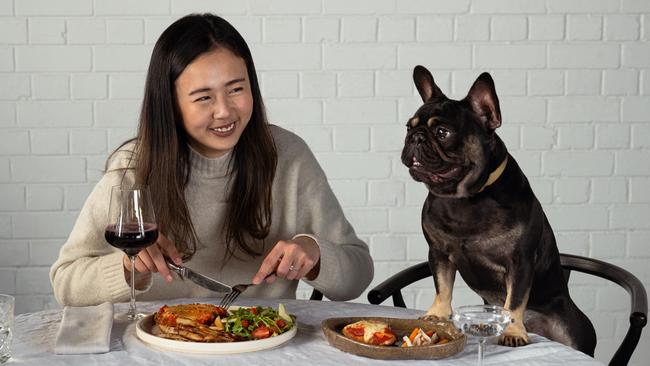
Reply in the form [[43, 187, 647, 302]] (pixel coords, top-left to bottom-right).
[[50, 149, 151, 306]]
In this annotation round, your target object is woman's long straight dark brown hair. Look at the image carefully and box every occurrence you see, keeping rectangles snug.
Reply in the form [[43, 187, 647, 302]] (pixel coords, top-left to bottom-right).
[[109, 14, 277, 260]]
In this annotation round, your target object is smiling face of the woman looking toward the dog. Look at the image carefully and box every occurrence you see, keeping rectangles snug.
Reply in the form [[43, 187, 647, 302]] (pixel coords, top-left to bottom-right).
[[176, 47, 253, 158]]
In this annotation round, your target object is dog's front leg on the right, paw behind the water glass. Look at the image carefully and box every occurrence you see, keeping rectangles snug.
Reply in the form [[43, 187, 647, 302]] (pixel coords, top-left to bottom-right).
[[499, 270, 532, 347]]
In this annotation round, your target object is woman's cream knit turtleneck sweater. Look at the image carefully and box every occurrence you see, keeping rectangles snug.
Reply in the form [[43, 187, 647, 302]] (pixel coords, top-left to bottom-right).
[[50, 126, 373, 306]]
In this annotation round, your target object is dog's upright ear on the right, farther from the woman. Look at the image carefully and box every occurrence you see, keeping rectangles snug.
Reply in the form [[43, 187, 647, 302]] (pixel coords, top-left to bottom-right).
[[466, 72, 501, 132]]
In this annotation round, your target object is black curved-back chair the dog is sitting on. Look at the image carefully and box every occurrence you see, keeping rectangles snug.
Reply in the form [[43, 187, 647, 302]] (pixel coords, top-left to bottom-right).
[[368, 254, 648, 365]]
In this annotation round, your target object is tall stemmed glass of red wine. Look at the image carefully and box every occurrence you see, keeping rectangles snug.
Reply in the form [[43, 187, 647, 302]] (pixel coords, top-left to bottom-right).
[[104, 186, 158, 320]]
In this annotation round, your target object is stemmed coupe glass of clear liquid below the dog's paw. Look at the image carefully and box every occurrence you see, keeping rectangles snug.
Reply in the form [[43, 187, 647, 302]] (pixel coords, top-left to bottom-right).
[[451, 305, 512, 366]]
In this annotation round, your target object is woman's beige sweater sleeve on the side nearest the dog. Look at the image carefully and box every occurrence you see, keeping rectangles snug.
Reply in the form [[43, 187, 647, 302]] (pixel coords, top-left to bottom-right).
[[296, 140, 374, 301]]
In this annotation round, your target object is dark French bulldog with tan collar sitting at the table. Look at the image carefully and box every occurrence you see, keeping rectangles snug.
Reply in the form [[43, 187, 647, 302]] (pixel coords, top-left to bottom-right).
[[401, 66, 596, 356]]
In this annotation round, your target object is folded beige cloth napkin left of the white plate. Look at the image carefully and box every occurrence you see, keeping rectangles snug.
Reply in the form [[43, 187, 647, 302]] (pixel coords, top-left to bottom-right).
[[54, 302, 113, 355]]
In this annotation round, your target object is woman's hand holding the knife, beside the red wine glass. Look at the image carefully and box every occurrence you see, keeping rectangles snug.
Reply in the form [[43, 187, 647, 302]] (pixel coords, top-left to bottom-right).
[[122, 234, 183, 282]]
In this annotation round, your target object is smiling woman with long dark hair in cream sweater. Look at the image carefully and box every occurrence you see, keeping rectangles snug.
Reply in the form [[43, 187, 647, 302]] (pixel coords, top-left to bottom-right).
[[50, 14, 373, 306]]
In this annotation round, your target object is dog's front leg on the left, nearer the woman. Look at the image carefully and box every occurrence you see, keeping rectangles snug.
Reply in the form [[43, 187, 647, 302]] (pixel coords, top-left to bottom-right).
[[423, 251, 456, 320]]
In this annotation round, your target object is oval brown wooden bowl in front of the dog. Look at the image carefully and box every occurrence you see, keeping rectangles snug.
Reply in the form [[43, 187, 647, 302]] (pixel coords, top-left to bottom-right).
[[321, 317, 466, 360]]
